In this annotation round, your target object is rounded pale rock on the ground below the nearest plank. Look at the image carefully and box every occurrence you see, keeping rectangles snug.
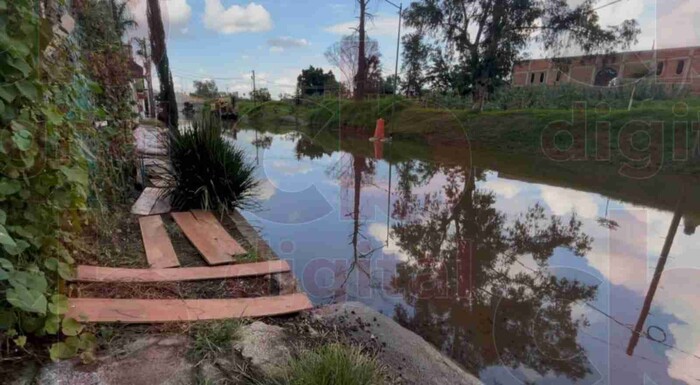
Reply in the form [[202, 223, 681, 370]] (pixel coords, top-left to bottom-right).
[[234, 321, 291, 376]]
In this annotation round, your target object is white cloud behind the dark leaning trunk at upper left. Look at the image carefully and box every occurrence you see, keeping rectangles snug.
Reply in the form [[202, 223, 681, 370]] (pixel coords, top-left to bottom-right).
[[128, 0, 192, 37]]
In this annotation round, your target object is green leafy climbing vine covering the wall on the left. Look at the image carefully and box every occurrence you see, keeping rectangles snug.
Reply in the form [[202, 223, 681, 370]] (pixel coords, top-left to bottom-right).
[[0, 0, 137, 360]]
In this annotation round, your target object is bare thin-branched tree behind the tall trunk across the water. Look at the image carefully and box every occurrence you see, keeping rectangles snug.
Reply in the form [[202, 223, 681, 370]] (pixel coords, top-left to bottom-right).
[[325, 34, 381, 92]]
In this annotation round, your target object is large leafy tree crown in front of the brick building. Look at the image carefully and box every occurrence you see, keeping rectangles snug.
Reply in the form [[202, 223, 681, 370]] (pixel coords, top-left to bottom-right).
[[406, 0, 640, 108]]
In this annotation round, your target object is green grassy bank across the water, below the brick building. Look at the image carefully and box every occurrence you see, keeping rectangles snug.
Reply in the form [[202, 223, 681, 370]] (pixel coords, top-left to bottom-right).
[[309, 99, 700, 173]]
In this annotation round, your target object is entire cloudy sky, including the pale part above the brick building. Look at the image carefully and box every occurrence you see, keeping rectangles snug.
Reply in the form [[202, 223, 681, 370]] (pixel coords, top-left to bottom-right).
[[128, 0, 700, 97]]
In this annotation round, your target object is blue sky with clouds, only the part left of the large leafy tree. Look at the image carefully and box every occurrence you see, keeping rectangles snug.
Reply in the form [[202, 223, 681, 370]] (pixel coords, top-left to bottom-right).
[[132, 0, 408, 97]]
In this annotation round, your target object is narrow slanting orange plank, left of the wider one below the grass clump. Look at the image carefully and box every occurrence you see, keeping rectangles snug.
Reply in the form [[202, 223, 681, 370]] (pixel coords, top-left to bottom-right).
[[139, 215, 180, 268]]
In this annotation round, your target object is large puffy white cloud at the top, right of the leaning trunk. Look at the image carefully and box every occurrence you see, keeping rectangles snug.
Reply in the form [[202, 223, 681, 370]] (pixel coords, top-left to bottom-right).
[[202, 0, 272, 34]]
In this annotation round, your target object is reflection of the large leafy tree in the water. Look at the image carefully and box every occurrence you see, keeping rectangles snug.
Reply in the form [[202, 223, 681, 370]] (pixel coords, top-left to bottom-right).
[[391, 164, 596, 380]]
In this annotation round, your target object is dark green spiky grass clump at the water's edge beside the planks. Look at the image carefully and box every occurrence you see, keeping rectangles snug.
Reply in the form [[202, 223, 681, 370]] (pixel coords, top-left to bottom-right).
[[167, 116, 259, 210]]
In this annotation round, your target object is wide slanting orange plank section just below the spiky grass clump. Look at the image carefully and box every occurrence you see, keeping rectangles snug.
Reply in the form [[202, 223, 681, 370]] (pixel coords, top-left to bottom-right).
[[172, 210, 246, 265]]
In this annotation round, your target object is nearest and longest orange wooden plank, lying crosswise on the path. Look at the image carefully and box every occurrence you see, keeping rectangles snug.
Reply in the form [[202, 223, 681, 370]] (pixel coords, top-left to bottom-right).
[[66, 293, 313, 323]]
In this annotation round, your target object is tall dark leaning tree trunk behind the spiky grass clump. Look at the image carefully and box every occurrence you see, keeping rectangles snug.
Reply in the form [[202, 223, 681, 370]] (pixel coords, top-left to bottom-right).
[[147, 0, 178, 130]]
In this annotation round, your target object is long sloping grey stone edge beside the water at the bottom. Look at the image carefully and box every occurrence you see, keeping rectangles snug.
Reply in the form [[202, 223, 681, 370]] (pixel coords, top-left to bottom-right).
[[314, 302, 481, 385]]
